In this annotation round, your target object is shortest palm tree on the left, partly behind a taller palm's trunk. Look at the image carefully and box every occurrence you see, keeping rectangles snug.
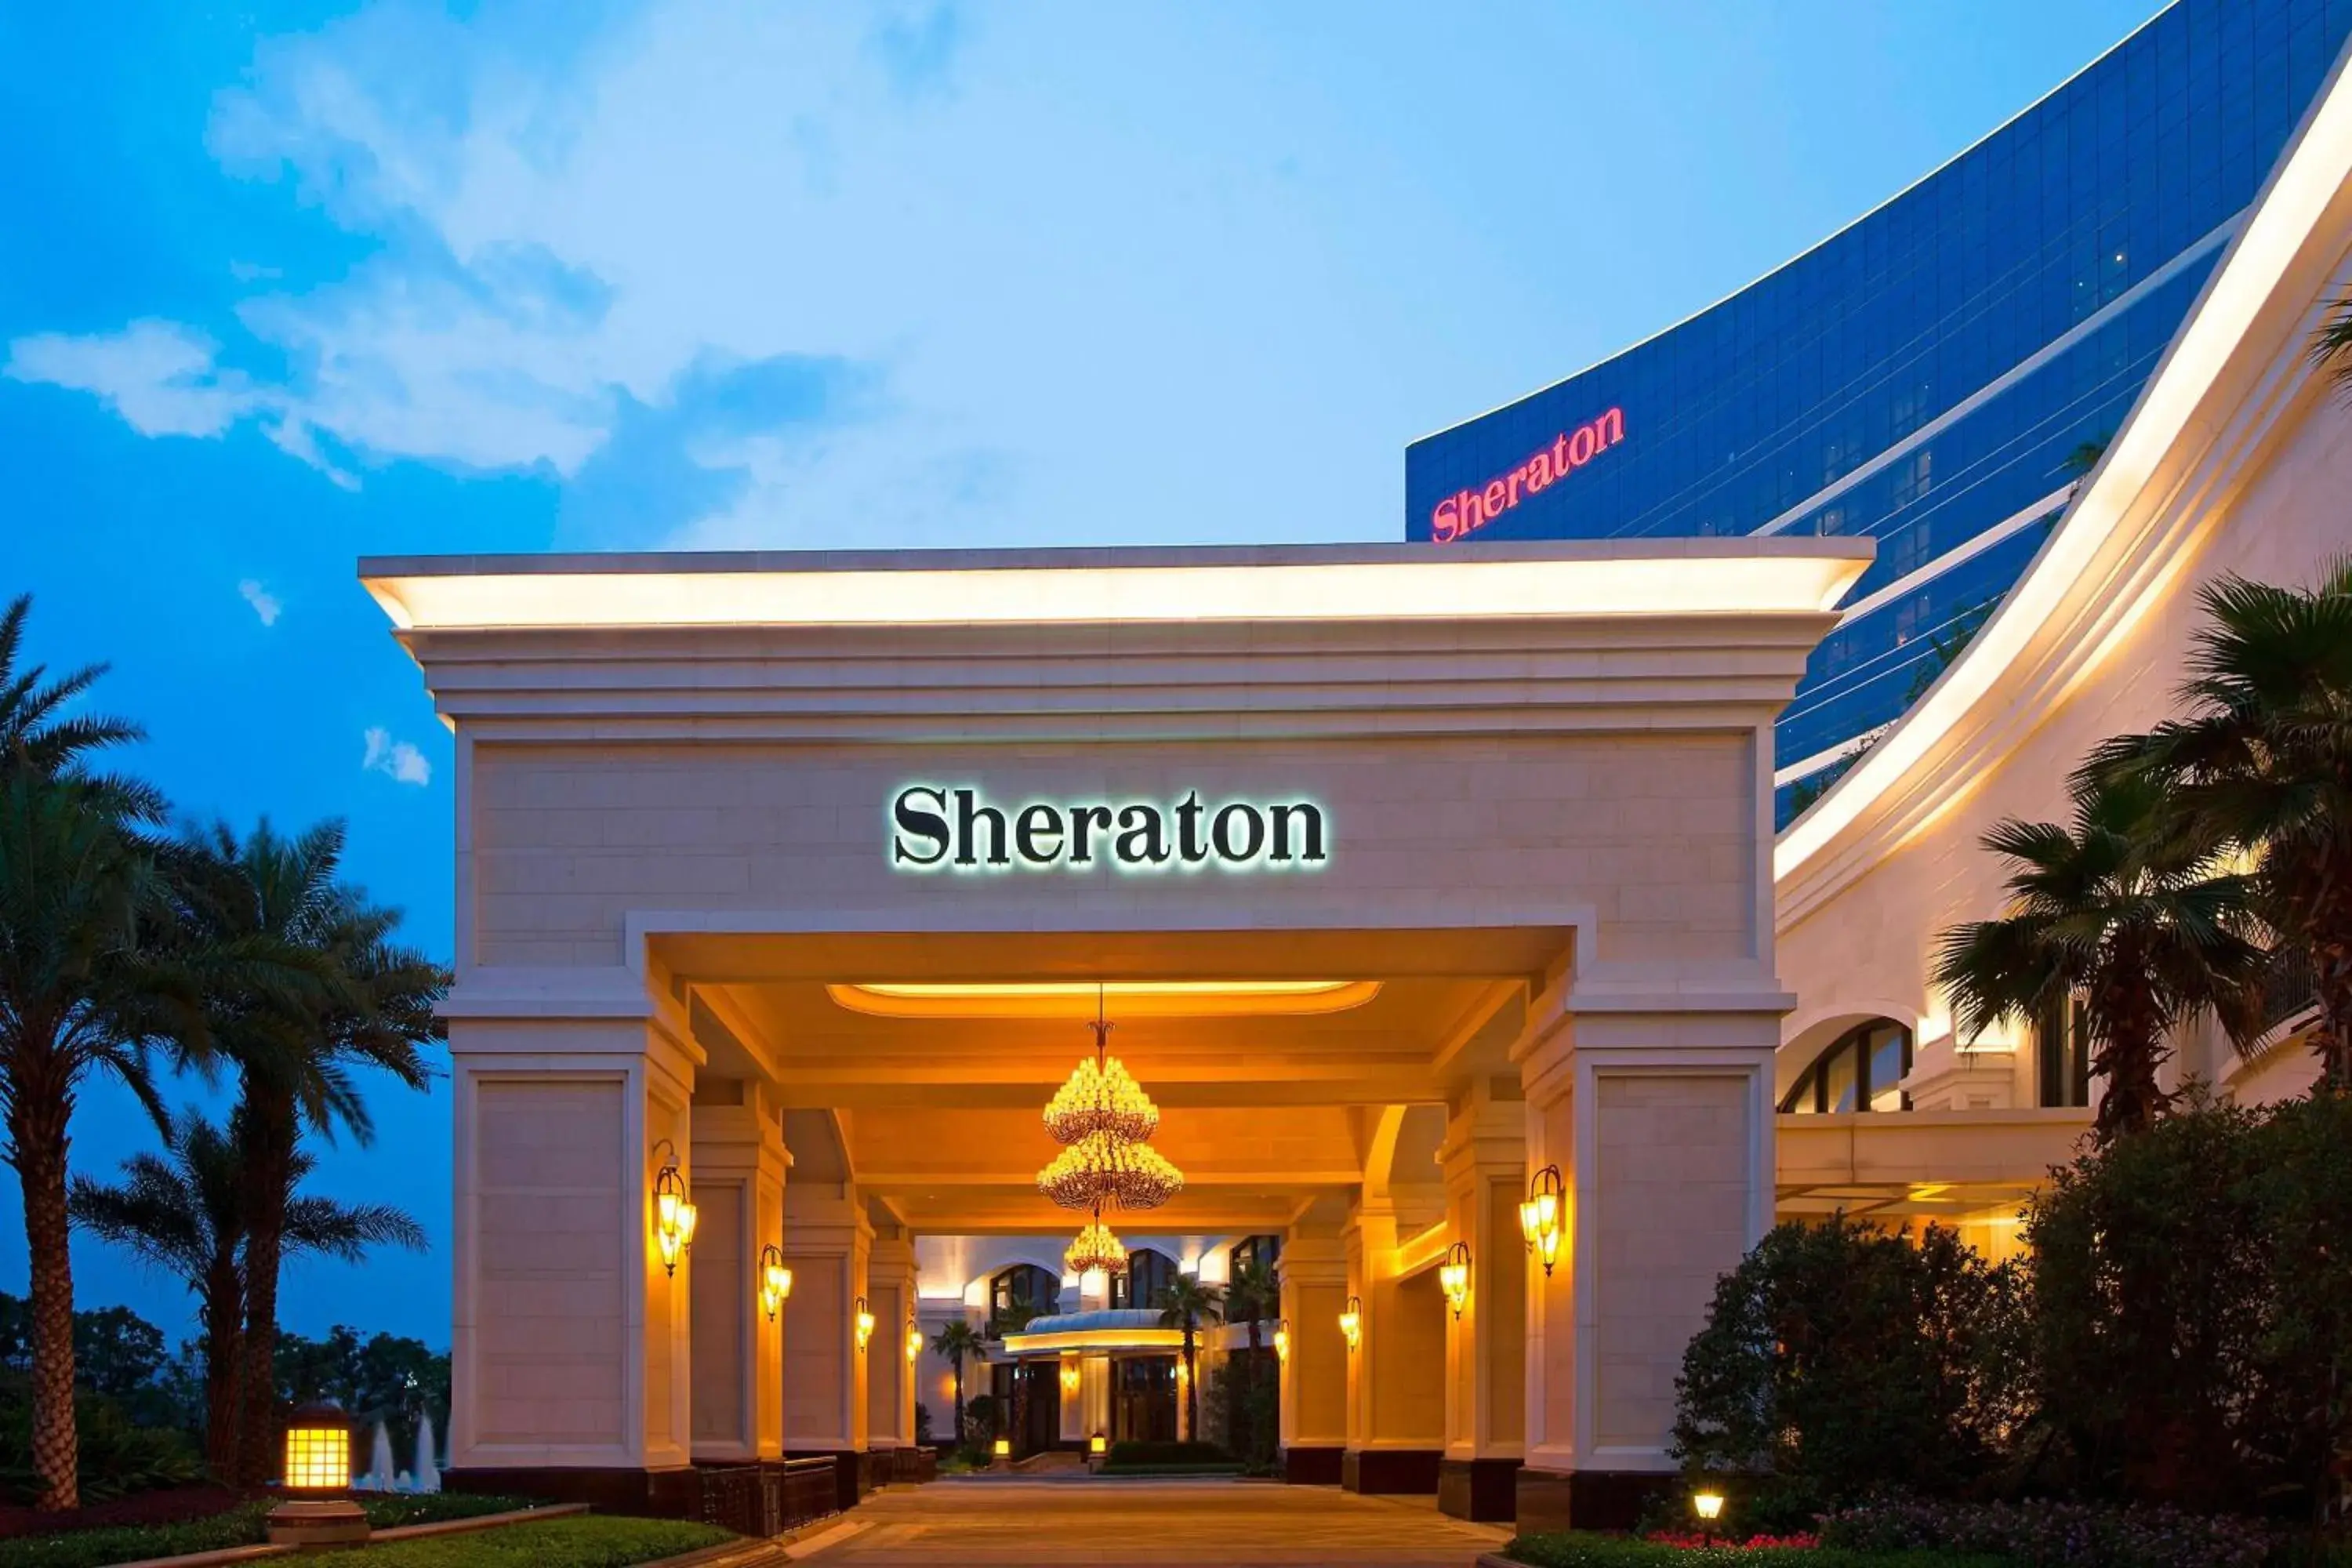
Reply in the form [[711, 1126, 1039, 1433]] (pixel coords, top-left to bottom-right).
[[71, 1109, 426, 1476]]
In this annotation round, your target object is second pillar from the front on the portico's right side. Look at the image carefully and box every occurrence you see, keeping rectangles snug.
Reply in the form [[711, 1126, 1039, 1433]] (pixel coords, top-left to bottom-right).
[[1437, 1079, 1529, 1521]]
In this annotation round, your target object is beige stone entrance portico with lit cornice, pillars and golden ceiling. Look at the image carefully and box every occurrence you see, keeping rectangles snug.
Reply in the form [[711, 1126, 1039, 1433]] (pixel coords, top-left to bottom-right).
[[365, 541, 1867, 1514]]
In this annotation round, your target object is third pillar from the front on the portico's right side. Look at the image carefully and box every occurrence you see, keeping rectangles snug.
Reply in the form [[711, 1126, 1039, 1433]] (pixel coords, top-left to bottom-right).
[[1341, 1203, 1446, 1495]]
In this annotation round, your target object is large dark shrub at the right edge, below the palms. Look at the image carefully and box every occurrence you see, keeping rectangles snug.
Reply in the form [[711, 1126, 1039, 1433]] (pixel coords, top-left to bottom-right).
[[2025, 1098, 2352, 1519]]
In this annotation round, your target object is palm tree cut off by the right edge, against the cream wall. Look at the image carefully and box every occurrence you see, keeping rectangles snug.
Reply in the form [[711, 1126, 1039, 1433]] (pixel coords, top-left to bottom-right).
[[2089, 564, 2352, 1093]]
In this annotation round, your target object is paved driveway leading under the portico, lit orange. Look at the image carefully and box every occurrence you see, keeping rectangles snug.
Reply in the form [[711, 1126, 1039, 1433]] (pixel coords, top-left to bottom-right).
[[793, 1479, 1510, 1568]]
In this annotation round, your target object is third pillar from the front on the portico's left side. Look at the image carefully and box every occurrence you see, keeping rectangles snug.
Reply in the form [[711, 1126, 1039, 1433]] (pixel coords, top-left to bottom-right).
[[783, 1180, 882, 1507]]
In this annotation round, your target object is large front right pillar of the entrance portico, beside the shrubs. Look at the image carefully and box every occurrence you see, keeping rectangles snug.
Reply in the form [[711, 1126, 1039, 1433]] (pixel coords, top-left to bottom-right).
[[1512, 975, 1790, 1530]]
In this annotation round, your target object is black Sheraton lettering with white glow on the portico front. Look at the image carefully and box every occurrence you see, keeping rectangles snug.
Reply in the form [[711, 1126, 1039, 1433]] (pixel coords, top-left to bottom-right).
[[889, 785, 1331, 872]]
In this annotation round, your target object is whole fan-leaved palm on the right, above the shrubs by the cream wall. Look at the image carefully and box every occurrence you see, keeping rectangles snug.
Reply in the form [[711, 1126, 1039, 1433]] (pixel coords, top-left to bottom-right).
[[1936, 774, 2265, 1142]]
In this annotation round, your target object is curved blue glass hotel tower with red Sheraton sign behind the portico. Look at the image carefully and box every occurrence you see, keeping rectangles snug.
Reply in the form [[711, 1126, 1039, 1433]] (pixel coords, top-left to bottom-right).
[[1404, 0, 2352, 820]]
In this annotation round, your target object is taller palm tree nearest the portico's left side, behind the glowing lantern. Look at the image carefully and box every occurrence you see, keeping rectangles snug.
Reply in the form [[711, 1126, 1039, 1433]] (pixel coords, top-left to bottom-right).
[[176, 820, 449, 1486]]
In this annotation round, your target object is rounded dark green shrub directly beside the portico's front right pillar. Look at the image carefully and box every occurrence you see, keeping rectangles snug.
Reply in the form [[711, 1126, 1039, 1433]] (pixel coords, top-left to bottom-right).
[[1675, 1215, 2025, 1530]]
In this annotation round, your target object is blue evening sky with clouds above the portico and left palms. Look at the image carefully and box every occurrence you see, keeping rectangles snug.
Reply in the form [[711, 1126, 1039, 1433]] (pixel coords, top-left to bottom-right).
[[0, 0, 2154, 1342]]
